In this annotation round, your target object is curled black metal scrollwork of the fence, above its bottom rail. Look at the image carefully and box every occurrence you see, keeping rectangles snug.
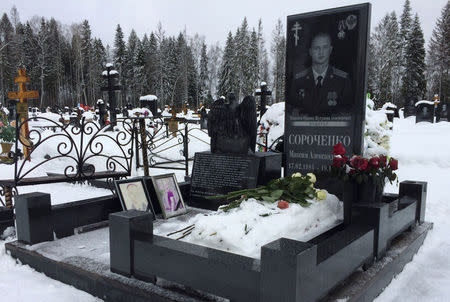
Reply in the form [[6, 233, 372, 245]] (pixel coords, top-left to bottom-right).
[[15, 117, 136, 184]]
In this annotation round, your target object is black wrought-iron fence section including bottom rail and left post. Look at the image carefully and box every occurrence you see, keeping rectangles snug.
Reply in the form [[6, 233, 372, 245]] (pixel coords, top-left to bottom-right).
[[0, 117, 136, 207]]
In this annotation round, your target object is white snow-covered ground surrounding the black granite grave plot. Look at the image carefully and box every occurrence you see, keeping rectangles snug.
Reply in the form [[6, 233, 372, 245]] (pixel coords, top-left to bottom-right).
[[0, 117, 450, 302]]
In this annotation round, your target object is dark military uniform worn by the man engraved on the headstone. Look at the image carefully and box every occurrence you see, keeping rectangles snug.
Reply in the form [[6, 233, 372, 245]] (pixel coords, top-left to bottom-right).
[[294, 66, 352, 114]]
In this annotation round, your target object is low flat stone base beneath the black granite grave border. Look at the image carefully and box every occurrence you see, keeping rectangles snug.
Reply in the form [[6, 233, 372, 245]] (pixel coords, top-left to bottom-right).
[[5, 217, 433, 302]]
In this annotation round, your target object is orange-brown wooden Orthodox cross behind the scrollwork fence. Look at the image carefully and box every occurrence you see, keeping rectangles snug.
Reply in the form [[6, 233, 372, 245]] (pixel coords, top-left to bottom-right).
[[8, 69, 39, 160]]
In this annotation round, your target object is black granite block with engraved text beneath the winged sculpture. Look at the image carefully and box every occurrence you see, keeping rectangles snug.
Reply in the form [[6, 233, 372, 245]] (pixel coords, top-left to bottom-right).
[[187, 152, 282, 210]]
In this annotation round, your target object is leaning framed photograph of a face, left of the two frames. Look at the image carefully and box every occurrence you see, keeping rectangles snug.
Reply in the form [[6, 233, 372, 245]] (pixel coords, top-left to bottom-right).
[[114, 177, 155, 217]]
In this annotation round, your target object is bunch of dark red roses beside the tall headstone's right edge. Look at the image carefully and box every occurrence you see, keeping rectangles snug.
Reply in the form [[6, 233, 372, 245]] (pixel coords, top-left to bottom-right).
[[331, 143, 398, 187]]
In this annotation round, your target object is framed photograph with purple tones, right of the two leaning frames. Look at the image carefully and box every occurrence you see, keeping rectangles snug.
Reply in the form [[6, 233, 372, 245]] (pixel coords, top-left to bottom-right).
[[151, 173, 186, 219]]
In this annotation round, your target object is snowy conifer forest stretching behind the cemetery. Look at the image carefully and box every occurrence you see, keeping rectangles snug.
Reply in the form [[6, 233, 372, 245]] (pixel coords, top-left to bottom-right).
[[0, 0, 450, 108]]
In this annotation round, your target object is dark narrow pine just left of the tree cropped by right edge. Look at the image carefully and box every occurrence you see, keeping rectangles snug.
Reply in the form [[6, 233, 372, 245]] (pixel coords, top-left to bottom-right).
[[402, 14, 426, 100]]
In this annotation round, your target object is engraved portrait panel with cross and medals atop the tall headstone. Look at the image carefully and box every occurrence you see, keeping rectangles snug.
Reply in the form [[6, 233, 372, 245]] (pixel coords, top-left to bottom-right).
[[286, 6, 370, 115]]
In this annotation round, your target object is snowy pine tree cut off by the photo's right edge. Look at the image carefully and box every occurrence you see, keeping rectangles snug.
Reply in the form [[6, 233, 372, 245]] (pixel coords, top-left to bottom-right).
[[427, 2, 450, 103]]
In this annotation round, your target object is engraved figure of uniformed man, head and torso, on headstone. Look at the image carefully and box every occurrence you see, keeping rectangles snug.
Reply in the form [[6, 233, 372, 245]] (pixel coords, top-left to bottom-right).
[[293, 32, 352, 114]]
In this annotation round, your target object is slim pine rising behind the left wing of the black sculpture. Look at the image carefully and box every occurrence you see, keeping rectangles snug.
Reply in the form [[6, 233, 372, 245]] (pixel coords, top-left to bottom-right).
[[217, 31, 236, 97]]
